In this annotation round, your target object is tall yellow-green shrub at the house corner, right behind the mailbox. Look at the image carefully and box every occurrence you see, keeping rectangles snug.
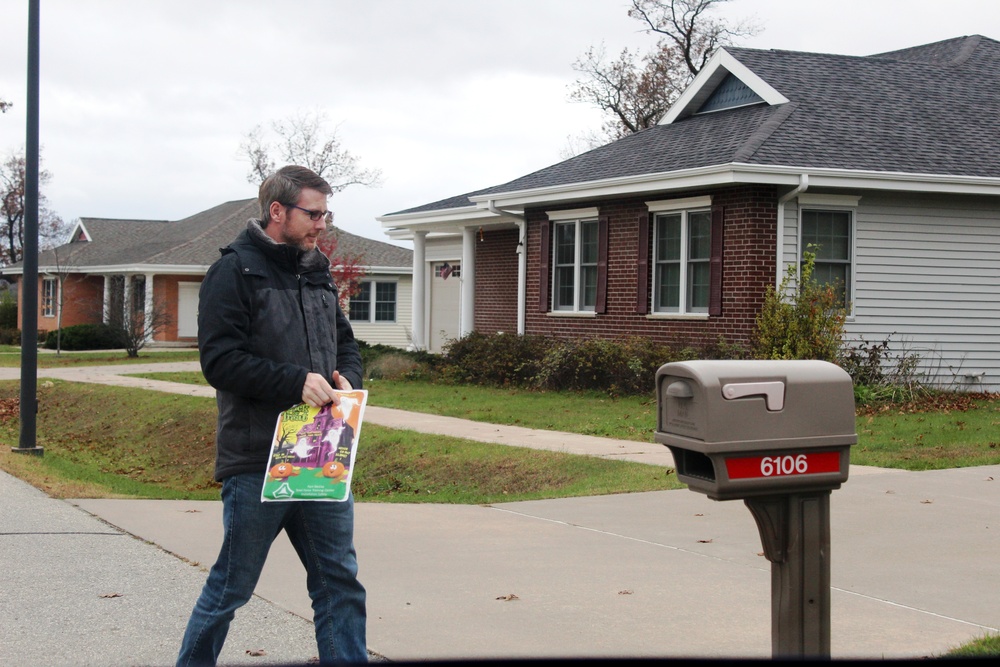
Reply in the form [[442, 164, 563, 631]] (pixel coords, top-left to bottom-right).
[[753, 251, 847, 363]]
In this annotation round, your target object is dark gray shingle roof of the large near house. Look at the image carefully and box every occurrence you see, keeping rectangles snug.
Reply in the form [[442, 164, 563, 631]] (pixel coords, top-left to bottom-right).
[[390, 35, 1000, 213]]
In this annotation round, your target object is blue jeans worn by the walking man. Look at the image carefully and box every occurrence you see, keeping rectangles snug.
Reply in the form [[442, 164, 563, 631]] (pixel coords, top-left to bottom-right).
[[177, 473, 368, 666]]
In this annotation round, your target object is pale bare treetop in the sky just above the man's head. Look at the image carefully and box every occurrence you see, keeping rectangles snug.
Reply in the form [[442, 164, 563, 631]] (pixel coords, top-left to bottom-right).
[[240, 111, 382, 189]]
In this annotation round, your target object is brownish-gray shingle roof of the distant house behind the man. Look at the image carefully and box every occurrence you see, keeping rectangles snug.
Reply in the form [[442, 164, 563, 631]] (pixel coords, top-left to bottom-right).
[[27, 199, 413, 269]]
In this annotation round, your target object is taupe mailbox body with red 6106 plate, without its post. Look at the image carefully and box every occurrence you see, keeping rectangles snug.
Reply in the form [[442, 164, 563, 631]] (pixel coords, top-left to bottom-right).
[[656, 361, 858, 500]]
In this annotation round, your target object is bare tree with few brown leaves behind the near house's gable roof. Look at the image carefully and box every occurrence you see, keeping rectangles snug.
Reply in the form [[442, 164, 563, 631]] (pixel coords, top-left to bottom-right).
[[570, 0, 759, 146]]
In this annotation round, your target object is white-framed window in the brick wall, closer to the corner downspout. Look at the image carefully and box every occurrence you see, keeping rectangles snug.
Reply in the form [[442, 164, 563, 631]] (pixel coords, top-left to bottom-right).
[[648, 197, 712, 314]]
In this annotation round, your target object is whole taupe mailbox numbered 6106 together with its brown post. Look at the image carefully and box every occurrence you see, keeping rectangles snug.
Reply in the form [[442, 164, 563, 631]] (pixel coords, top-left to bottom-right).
[[656, 361, 857, 658]]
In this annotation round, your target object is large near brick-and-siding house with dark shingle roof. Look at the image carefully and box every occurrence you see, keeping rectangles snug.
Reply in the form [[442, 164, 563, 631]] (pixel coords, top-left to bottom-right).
[[379, 36, 1000, 391]]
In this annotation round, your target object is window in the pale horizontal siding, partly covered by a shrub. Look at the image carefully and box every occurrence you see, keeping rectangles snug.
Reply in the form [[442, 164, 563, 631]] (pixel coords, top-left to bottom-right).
[[799, 196, 858, 309]]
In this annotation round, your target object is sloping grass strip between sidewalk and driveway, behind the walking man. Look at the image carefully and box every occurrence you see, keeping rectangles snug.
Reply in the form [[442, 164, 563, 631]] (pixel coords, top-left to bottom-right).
[[0, 381, 681, 504]]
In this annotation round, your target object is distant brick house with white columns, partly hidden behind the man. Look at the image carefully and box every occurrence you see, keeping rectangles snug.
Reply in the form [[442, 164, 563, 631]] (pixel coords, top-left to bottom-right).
[[2, 199, 412, 348]]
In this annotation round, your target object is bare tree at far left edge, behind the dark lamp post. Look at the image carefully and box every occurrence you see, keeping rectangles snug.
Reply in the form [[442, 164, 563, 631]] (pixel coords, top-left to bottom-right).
[[0, 149, 66, 266]]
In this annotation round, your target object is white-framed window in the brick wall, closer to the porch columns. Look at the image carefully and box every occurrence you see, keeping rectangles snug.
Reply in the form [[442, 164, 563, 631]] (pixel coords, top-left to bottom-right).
[[549, 209, 600, 313]]
